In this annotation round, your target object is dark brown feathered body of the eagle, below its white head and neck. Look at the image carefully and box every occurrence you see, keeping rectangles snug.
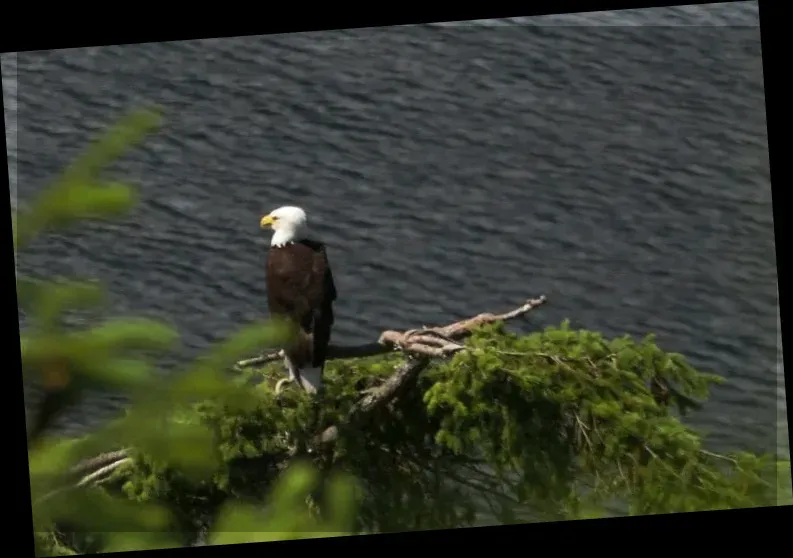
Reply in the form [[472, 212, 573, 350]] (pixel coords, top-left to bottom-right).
[[267, 240, 336, 388]]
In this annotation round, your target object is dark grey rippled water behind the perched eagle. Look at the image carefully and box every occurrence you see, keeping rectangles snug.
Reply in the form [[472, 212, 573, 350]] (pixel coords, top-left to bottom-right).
[[3, 2, 787, 462]]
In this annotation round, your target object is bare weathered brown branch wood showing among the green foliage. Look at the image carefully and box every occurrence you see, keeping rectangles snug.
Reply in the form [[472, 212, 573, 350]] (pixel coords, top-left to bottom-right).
[[70, 296, 547, 486]]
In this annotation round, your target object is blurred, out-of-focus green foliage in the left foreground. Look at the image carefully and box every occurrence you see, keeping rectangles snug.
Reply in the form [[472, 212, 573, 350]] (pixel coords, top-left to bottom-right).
[[20, 111, 354, 555]]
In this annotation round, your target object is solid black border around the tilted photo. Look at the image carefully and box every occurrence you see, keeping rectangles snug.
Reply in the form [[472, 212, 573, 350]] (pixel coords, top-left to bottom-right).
[[0, 0, 791, 556]]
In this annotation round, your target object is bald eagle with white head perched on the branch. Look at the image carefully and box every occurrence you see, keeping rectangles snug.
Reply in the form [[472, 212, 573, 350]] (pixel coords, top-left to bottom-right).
[[260, 206, 336, 393]]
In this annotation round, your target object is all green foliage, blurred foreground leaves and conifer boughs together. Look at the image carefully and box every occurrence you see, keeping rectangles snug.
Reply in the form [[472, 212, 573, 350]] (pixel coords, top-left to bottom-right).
[[15, 112, 791, 555]]
